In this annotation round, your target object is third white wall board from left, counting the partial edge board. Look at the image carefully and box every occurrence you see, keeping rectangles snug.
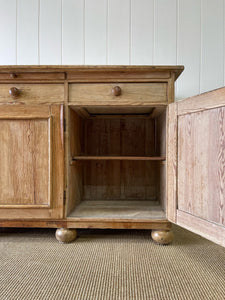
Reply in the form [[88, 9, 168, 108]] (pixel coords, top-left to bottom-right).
[[39, 0, 62, 65]]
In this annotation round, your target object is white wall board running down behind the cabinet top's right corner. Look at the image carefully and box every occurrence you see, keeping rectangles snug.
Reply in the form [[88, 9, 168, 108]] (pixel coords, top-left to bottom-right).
[[176, 0, 201, 99]]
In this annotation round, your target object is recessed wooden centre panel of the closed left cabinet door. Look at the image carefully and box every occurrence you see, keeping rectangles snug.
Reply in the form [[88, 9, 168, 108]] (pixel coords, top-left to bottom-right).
[[0, 119, 50, 206]]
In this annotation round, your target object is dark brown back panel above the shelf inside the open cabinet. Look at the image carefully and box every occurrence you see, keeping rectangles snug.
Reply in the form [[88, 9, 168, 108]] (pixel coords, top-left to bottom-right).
[[83, 118, 155, 156]]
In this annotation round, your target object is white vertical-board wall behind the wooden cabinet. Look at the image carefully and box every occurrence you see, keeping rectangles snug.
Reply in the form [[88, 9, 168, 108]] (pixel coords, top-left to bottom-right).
[[0, 0, 225, 99]]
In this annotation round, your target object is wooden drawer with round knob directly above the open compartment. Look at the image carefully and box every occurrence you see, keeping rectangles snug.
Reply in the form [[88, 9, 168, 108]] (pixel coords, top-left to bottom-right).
[[69, 82, 167, 105]]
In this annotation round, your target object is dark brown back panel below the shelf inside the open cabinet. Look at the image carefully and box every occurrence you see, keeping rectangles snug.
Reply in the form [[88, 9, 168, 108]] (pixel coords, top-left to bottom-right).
[[82, 161, 158, 200]]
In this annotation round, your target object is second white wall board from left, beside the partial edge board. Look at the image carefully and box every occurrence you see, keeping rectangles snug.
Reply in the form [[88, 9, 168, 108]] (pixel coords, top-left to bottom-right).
[[17, 0, 39, 65]]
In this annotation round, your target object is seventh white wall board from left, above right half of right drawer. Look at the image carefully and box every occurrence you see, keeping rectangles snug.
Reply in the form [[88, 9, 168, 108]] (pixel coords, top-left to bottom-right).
[[131, 0, 154, 65]]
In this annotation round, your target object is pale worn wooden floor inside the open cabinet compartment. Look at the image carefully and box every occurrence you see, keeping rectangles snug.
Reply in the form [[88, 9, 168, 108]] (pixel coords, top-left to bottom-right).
[[69, 200, 166, 220]]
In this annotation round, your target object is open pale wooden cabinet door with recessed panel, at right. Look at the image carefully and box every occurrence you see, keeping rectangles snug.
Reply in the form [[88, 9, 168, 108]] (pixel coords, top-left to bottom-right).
[[167, 88, 225, 246]]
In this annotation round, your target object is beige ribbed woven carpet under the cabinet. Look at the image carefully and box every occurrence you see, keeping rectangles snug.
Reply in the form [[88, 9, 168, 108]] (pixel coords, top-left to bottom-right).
[[0, 226, 225, 300]]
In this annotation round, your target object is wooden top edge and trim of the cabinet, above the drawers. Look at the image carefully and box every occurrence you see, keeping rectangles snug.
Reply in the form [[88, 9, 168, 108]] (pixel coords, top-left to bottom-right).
[[0, 65, 184, 82]]
